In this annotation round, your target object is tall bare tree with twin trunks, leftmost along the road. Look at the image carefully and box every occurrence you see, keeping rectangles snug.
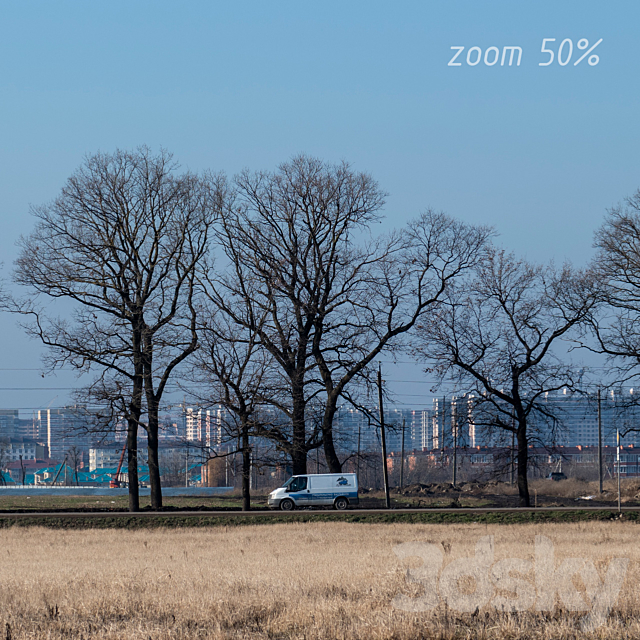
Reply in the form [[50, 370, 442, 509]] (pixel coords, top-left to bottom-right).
[[15, 147, 221, 510]]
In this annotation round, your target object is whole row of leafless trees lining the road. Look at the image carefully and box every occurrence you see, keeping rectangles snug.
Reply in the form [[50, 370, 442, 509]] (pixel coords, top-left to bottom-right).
[[5, 148, 640, 510]]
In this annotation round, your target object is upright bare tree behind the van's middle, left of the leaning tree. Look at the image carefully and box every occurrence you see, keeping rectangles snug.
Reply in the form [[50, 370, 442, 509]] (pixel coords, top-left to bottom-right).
[[209, 156, 384, 474]]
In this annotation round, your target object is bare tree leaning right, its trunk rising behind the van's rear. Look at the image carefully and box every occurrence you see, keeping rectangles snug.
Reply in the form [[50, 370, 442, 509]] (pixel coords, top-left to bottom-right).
[[312, 211, 492, 473]]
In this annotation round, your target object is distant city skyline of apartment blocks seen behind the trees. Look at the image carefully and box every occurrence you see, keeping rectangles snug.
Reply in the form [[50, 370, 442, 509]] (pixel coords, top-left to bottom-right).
[[0, 392, 640, 462]]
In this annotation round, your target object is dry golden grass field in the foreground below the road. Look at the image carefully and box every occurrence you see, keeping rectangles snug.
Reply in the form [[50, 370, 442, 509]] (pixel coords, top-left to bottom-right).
[[0, 521, 640, 640]]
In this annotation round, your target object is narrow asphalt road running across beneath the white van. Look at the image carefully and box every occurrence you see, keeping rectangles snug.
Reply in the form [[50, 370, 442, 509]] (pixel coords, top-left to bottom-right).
[[0, 506, 640, 519]]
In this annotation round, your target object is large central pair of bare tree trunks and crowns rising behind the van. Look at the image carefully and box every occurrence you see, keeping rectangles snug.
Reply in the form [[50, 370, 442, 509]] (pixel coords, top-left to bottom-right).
[[209, 156, 489, 474]]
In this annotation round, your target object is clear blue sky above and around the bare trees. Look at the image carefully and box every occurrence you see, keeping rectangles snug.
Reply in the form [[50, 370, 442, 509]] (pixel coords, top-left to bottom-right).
[[0, 0, 640, 408]]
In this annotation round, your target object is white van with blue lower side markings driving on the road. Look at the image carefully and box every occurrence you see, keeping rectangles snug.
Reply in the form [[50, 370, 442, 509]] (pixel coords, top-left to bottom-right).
[[269, 473, 359, 511]]
